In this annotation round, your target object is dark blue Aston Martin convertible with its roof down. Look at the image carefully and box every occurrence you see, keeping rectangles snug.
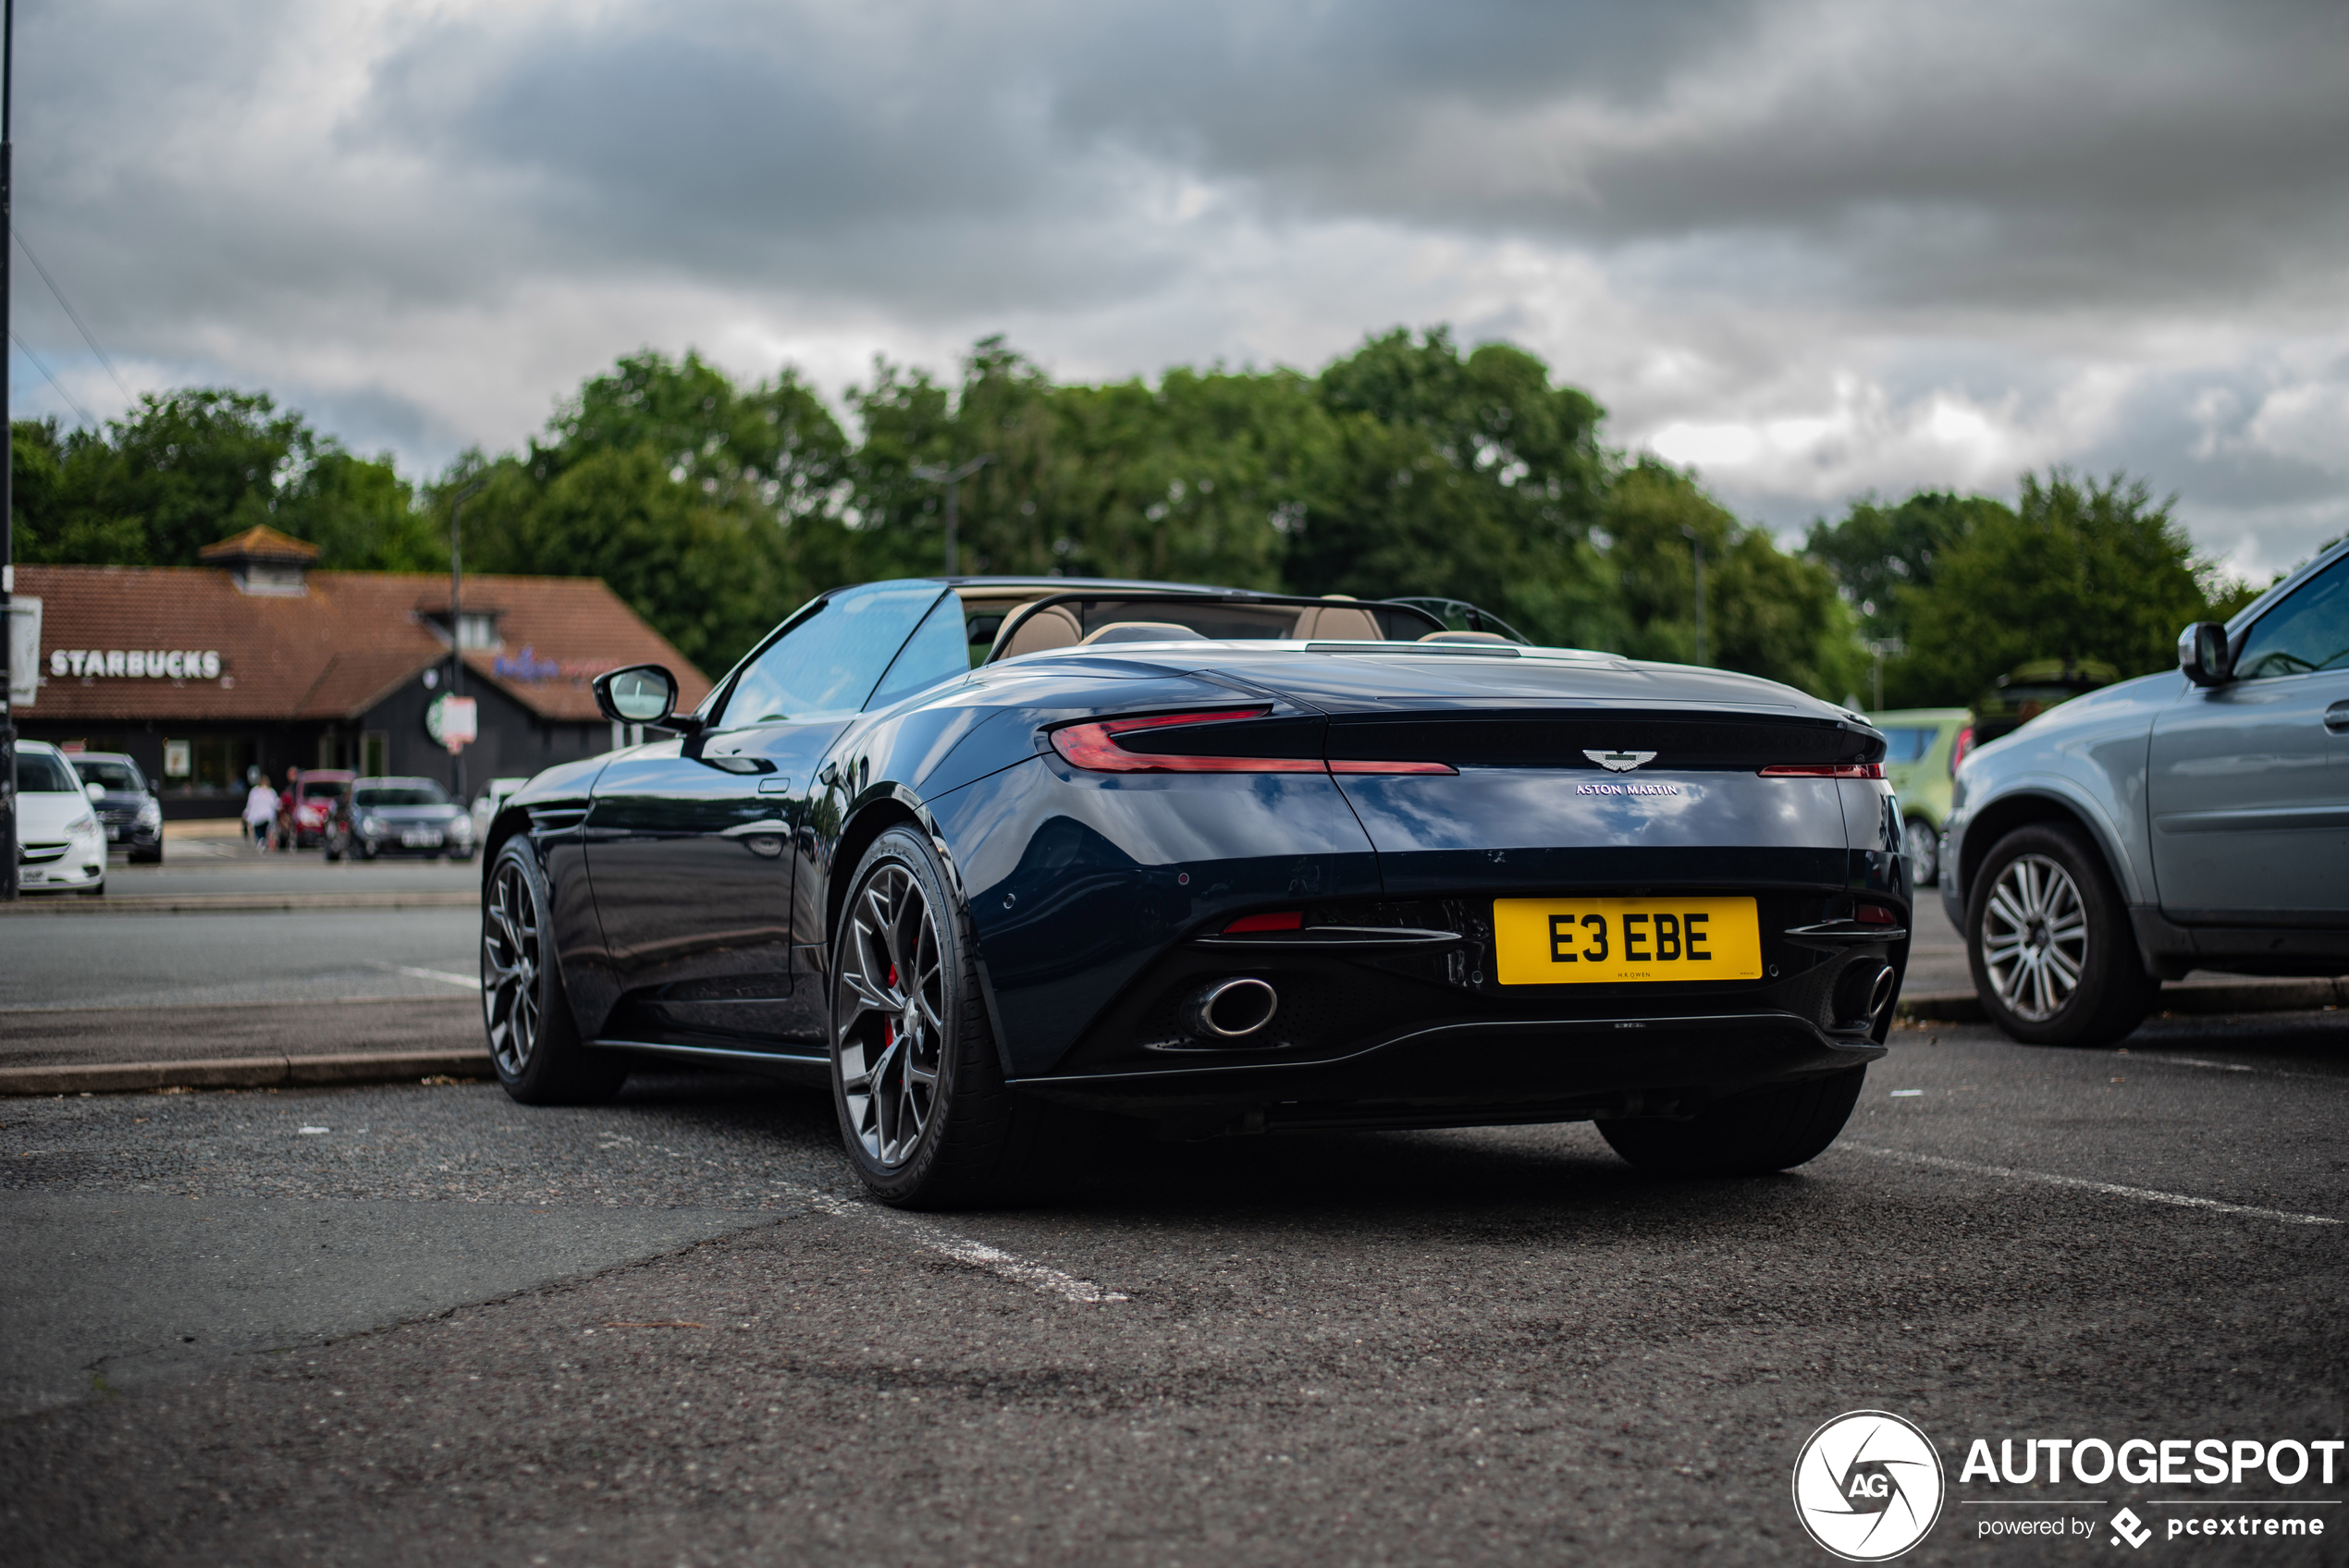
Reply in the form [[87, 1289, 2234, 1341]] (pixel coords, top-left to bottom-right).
[[482, 578, 1910, 1204]]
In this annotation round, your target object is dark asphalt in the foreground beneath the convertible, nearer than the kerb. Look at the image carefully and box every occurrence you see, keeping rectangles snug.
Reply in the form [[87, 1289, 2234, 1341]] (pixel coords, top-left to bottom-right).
[[0, 1014, 2349, 1568]]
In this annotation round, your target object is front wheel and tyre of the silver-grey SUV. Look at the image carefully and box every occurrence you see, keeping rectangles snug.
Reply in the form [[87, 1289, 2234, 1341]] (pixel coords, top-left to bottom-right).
[[1966, 822, 2161, 1047]]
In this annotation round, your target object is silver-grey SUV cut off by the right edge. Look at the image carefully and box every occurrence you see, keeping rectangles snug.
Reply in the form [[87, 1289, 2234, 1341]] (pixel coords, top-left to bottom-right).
[[1940, 540, 2349, 1045]]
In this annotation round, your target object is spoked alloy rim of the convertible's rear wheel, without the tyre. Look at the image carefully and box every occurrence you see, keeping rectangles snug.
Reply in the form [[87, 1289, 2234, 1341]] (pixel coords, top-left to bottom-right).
[[834, 864, 947, 1169]]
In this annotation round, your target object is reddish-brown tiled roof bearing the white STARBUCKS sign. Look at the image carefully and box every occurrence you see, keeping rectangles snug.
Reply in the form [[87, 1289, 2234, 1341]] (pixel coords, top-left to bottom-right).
[[17, 565, 709, 720]]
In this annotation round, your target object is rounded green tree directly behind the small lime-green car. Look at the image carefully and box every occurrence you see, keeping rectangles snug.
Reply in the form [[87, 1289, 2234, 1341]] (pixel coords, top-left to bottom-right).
[[1887, 467, 2236, 704]]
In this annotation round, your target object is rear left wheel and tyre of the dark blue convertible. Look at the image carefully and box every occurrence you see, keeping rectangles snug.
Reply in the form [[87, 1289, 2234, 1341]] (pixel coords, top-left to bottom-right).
[[831, 827, 1097, 1209]]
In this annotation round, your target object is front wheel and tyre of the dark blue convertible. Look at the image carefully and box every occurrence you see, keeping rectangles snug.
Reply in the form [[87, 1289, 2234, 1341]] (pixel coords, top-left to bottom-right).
[[482, 838, 627, 1106]]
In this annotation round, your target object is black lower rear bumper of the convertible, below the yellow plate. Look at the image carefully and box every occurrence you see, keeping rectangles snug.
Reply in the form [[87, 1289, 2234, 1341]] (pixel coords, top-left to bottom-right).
[[1013, 894, 1907, 1133]]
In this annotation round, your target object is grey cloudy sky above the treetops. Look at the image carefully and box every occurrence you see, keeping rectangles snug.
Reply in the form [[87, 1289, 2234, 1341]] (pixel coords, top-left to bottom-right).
[[12, 0, 2349, 572]]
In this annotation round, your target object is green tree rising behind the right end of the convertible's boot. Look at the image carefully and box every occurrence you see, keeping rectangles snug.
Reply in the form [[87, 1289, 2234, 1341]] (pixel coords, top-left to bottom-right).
[[1605, 458, 1863, 702]]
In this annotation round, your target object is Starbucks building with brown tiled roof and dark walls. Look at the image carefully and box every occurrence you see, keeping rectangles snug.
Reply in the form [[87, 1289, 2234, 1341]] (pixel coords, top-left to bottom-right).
[[17, 528, 709, 817]]
